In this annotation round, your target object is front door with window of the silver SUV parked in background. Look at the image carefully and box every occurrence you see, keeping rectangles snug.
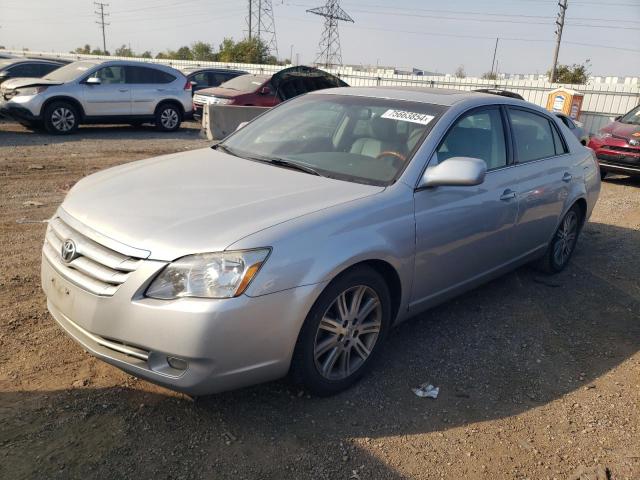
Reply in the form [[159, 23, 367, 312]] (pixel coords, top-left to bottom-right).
[[82, 65, 131, 117]]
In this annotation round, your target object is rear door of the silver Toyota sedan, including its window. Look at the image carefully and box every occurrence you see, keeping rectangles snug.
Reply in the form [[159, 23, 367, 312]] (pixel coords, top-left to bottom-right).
[[507, 107, 573, 254]]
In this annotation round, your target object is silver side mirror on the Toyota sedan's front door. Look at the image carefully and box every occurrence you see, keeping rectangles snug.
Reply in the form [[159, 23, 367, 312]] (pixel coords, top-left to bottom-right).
[[418, 157, 487, 188]]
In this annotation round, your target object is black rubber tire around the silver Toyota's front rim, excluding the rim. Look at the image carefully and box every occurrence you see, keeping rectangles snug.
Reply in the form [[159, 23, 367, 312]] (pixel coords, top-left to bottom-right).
[[291, 266, 391, 396]]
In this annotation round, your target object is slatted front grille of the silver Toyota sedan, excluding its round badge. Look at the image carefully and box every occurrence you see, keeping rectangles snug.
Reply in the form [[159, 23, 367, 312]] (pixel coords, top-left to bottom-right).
[[42, 217, 141, 296]]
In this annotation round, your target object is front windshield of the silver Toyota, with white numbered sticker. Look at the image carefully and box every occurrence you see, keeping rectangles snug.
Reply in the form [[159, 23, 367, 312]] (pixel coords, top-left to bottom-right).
[[221, 94, 446, 185]]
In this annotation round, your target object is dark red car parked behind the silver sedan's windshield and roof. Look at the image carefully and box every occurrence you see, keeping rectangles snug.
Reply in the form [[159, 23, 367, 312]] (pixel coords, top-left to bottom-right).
[[193, 66, 348, 115]]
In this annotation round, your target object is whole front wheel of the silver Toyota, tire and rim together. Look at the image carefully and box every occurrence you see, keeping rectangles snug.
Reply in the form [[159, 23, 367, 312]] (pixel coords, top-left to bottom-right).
[[290, 266, 391, 396]]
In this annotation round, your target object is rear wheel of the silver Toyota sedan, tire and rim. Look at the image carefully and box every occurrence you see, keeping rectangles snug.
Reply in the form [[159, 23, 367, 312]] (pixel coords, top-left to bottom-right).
[[538, 205, 582, 274]]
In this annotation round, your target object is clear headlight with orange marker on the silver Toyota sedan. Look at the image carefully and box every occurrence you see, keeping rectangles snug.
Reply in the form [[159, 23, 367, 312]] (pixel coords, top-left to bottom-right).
[[145, 248, 271, 300]]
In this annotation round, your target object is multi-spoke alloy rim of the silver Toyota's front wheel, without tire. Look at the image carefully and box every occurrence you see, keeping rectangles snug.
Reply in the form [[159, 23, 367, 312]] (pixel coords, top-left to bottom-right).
[[313, 285, 382, 380]]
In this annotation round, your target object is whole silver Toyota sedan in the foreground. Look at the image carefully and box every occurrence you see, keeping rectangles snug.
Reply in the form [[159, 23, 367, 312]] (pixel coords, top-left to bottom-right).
[[42, 88, 600, 395]]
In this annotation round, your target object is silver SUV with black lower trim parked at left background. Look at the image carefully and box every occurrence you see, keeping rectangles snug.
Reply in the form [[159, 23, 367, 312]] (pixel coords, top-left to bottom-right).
[[0, 60, 192, 134]]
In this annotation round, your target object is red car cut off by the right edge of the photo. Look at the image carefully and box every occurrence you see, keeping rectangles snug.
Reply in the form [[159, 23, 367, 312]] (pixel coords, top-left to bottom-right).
[[589, 105, 640, 178]]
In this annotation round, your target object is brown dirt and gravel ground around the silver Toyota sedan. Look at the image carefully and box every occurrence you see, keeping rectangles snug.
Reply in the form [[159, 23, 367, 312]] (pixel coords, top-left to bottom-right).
[[0, 122, 640, 480]]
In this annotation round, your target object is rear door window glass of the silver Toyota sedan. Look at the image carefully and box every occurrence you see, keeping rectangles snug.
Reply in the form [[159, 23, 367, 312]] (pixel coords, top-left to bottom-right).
[[509, 109, 556, 163]]
